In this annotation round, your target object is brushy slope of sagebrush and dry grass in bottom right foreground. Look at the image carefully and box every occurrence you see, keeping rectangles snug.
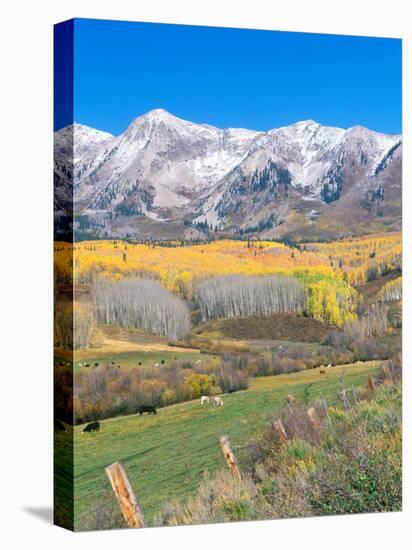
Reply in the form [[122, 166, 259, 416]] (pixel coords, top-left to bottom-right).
[[156, 378, 402, 526]]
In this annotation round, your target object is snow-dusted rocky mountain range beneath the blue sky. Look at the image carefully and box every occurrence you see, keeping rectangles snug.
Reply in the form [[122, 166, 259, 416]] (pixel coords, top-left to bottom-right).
[[55, 109, 402, 242]]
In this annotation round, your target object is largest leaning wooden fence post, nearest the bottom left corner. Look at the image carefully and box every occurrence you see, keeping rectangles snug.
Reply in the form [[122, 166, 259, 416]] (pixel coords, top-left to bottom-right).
[[105, 462, 146, 529]]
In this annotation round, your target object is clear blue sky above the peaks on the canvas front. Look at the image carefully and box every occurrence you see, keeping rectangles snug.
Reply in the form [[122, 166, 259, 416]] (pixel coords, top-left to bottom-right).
[[56, 19, 402, 134]]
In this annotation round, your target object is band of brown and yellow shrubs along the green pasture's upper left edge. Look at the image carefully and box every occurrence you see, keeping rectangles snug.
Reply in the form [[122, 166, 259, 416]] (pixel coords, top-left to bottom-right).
[[67, 356, 248, 424]]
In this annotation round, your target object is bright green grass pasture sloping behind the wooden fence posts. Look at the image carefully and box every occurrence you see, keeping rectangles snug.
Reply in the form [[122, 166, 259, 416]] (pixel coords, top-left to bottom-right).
[[56, 362, 377, 529]]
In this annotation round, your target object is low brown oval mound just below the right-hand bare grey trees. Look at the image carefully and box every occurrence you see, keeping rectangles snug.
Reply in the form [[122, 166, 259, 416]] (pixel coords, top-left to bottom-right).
[[196, 314, 332, 342]]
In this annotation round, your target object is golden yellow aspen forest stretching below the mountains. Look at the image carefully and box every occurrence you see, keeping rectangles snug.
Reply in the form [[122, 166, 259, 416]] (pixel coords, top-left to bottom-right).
[[55, 234, 401, 336]]
